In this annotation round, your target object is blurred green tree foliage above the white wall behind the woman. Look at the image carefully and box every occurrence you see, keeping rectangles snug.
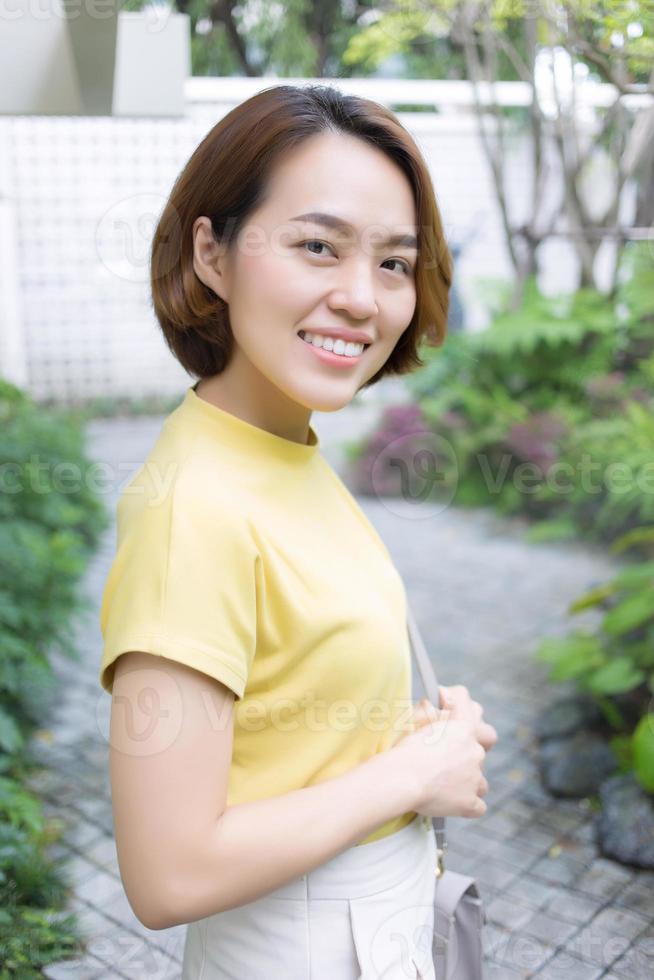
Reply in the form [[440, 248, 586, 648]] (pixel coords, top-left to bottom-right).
[[122, 0, 654, 82]]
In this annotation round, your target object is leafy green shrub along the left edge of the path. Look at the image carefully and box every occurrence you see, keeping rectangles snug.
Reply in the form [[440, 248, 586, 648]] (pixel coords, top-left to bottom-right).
[[0, 381, 109, 978]]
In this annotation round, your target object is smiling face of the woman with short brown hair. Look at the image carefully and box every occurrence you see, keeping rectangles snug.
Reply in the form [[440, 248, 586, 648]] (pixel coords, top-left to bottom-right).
[[194, 132, 417, 415]]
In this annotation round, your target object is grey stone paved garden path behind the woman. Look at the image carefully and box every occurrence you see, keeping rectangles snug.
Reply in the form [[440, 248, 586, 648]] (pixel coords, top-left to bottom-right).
[[33, 384, 654, 980]]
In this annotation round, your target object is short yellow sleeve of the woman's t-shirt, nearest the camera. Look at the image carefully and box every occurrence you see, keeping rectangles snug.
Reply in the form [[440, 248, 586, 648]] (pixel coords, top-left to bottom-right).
[[100, 470, 258, 698]]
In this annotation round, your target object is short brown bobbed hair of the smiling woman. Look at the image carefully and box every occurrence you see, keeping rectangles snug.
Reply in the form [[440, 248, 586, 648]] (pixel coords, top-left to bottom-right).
[[150, 85, 452, 388]]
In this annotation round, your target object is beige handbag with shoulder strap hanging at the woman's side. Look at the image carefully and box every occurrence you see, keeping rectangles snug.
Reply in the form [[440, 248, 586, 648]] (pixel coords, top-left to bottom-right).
[[407, 604, 486, 980]]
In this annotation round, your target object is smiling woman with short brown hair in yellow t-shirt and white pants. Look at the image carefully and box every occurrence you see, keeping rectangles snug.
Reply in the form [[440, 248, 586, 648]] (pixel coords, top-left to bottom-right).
[[100, 85, 497, 980]]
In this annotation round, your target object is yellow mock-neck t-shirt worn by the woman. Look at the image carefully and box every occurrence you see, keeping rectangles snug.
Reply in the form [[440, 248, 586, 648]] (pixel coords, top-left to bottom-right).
[[100, 388, 416, 844]]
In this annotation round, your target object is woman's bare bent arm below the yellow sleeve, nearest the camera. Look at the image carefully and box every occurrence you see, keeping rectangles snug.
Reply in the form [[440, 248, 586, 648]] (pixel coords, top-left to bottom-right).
[[110, 651, 419, 929]]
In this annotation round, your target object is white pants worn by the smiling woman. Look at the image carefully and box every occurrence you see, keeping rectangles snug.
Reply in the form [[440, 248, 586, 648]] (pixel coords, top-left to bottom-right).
[[182, 816, 436, 980]]
